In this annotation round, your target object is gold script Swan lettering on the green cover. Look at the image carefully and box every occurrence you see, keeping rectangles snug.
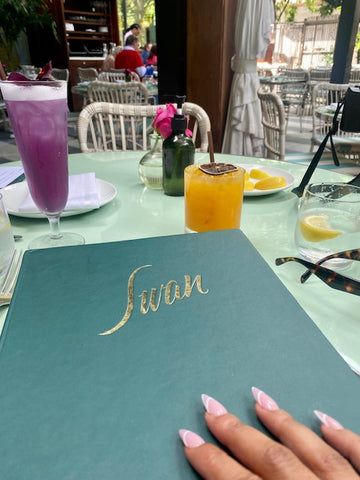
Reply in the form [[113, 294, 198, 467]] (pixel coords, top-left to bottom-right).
[[99, 265, 209, 335]]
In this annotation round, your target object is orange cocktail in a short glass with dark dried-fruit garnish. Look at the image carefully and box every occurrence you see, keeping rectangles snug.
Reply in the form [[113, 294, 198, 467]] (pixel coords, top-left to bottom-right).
[[185, 164, 245, 232]]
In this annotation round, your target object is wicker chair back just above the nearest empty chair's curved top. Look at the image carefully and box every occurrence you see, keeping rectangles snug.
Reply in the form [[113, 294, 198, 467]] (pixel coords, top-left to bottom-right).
[[88, 81, 149, 104]]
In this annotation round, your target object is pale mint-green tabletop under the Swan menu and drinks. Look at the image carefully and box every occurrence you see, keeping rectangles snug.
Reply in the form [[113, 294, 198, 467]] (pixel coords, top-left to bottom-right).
[[0, 152, 360, 370]]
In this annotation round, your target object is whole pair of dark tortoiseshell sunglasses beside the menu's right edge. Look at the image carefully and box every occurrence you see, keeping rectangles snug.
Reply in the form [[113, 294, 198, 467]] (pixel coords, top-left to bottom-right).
[[275, 248, 360, 295]]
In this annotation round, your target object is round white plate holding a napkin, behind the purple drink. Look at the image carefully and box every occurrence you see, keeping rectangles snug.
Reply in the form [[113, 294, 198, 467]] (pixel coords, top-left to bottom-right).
[[0, 178, 117, 218]]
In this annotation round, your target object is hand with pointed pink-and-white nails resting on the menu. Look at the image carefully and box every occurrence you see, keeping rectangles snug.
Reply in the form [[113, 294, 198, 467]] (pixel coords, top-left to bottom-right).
[[179, 387, 360, 480]]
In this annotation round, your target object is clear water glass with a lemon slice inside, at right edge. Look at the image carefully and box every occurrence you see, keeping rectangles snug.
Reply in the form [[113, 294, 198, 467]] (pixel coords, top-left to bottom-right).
[[295, 183, 360, 267]]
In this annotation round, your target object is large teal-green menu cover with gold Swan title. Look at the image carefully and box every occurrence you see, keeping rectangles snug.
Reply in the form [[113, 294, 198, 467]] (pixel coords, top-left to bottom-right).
[[0, 231, 360, 480]]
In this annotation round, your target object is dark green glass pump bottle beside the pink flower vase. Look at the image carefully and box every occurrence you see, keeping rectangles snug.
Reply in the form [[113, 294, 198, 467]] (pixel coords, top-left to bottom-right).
[[163, 113, 195, 196]]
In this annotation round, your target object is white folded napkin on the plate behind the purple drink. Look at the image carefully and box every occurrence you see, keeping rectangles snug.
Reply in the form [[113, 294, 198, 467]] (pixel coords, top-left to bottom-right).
[[19, 172, 100, 213]]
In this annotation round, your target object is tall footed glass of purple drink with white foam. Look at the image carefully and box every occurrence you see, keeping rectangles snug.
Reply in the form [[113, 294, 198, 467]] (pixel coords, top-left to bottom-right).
[[0, 81, 84, 248]]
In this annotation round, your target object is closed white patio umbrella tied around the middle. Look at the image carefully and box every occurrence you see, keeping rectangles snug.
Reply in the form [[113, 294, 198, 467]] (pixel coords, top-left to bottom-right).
[[222, 0, 274, 156]]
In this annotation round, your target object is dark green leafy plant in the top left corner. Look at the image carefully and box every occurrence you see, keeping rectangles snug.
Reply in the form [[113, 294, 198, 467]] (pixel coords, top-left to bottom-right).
[[0, 0, 56, 71]]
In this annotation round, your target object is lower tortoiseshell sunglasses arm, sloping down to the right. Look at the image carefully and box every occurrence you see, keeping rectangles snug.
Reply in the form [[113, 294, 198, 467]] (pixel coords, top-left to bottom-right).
[[275, 257, 360, 295]]
